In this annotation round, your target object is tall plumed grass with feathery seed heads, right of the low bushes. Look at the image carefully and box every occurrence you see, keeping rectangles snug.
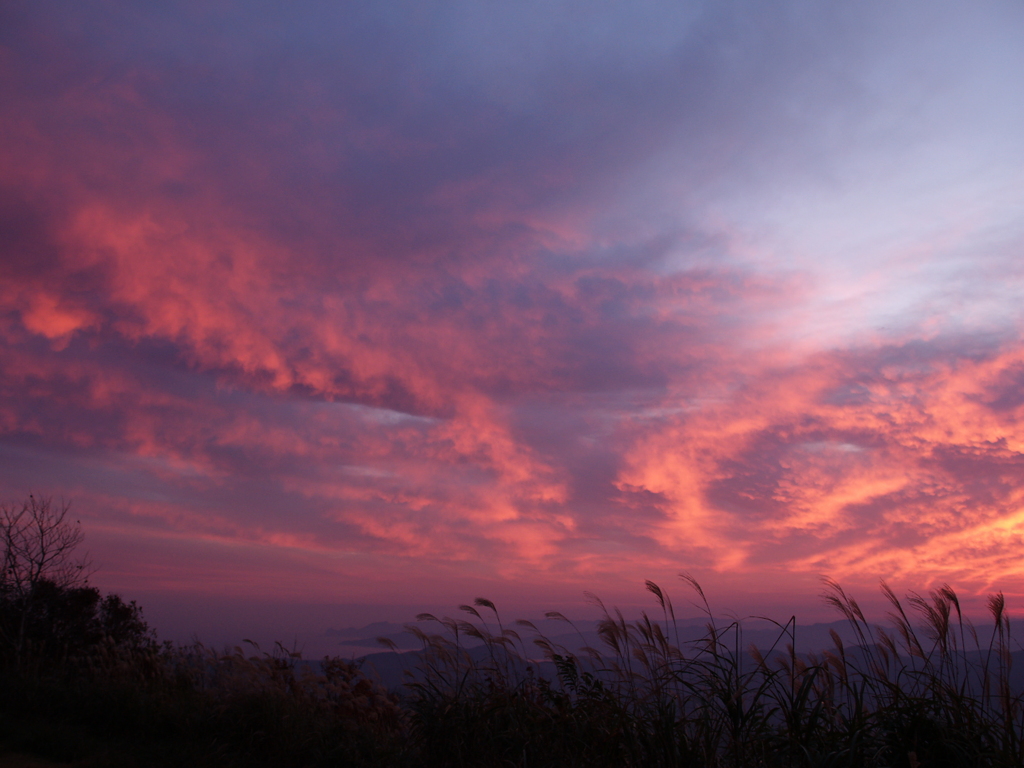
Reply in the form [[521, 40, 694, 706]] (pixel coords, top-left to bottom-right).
[[410, 575, 1024, 768]]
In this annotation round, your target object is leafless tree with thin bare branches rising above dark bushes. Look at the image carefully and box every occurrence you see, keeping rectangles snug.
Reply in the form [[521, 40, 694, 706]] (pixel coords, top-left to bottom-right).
[[0, 496, 88, 599]]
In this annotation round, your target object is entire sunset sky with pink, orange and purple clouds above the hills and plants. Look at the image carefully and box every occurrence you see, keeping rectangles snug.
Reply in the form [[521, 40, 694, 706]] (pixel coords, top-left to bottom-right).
[[0, 0, 1024, 643]]
